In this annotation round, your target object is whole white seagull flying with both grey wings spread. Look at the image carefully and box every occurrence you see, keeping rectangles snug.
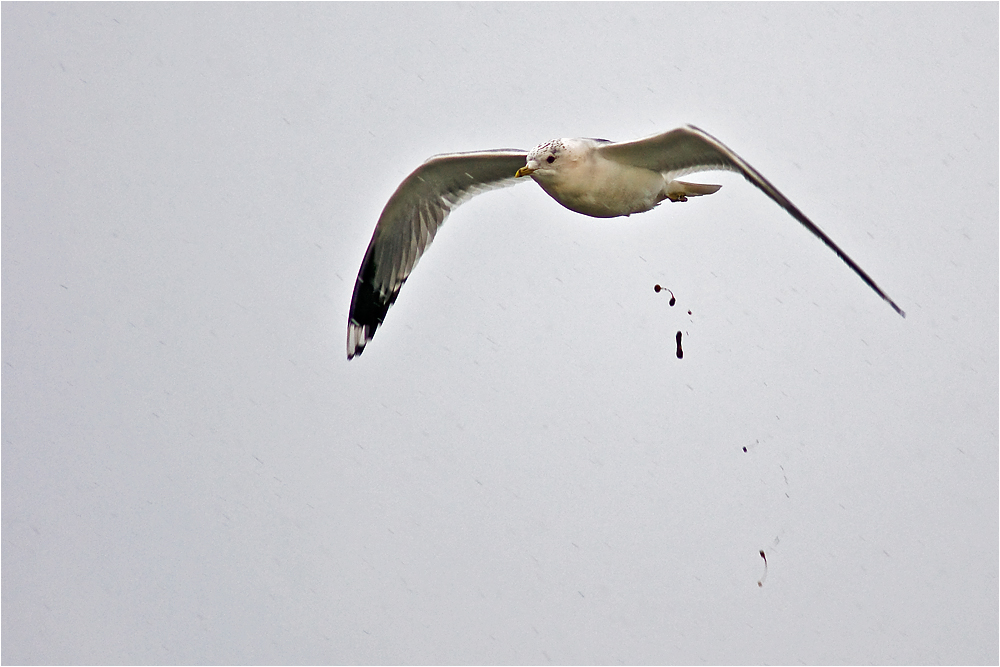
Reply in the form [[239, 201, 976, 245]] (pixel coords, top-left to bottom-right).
[[347, 125, 906, 359]]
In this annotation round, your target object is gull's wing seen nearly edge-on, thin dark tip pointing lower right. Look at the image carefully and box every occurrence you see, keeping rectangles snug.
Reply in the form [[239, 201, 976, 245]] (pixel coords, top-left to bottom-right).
[[597, 125, 906, 317]]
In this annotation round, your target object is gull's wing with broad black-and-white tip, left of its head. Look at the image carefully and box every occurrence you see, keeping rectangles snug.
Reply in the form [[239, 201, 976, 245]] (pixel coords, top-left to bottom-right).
[[347, 149, 527, 359]]
